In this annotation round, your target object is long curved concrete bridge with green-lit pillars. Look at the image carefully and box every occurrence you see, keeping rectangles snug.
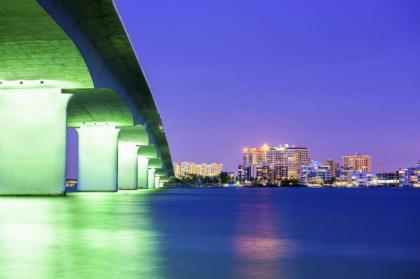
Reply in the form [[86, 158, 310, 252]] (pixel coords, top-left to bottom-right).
[[0, 0, 173, 195]]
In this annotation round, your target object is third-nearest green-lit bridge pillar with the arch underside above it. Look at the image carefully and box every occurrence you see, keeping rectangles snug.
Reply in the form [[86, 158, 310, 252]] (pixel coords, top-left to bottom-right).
[[118, 125, 149, 190]]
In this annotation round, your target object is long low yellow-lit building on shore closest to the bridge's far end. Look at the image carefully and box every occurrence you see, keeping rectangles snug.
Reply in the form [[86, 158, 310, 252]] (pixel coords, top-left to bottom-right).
[[175, 162, 223, 178]]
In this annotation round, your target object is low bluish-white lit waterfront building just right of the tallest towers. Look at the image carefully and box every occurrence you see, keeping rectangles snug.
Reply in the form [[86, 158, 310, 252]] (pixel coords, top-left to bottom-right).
[[299, 160, 332, 186]]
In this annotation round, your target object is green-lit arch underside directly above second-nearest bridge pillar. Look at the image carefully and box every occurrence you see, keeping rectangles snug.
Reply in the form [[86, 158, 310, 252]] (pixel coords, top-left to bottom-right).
[[63, 88, 133, 128]]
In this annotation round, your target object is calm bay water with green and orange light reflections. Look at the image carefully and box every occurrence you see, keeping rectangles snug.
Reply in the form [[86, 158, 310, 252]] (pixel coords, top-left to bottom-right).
[[0, 188, 420, 279]]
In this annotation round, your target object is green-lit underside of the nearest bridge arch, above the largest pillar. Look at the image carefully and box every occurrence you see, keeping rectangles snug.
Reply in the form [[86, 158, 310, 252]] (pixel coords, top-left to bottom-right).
[[0, 0, 93, 88]]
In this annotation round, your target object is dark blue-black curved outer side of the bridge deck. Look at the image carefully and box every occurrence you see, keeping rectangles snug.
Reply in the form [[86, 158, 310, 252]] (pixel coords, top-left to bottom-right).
[[36, 0, 173, 176]]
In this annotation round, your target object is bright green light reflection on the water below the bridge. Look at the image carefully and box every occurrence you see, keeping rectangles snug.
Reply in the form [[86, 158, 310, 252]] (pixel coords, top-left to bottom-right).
[[0, 190, 164, 279]]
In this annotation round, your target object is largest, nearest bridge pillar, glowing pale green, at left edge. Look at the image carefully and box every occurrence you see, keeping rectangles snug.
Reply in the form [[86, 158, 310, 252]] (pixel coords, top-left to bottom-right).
[[0, 89, 71, 195]]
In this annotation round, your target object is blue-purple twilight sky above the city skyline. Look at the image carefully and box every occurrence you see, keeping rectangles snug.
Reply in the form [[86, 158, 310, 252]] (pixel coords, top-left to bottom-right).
[[67, 0, 420, 178]]
